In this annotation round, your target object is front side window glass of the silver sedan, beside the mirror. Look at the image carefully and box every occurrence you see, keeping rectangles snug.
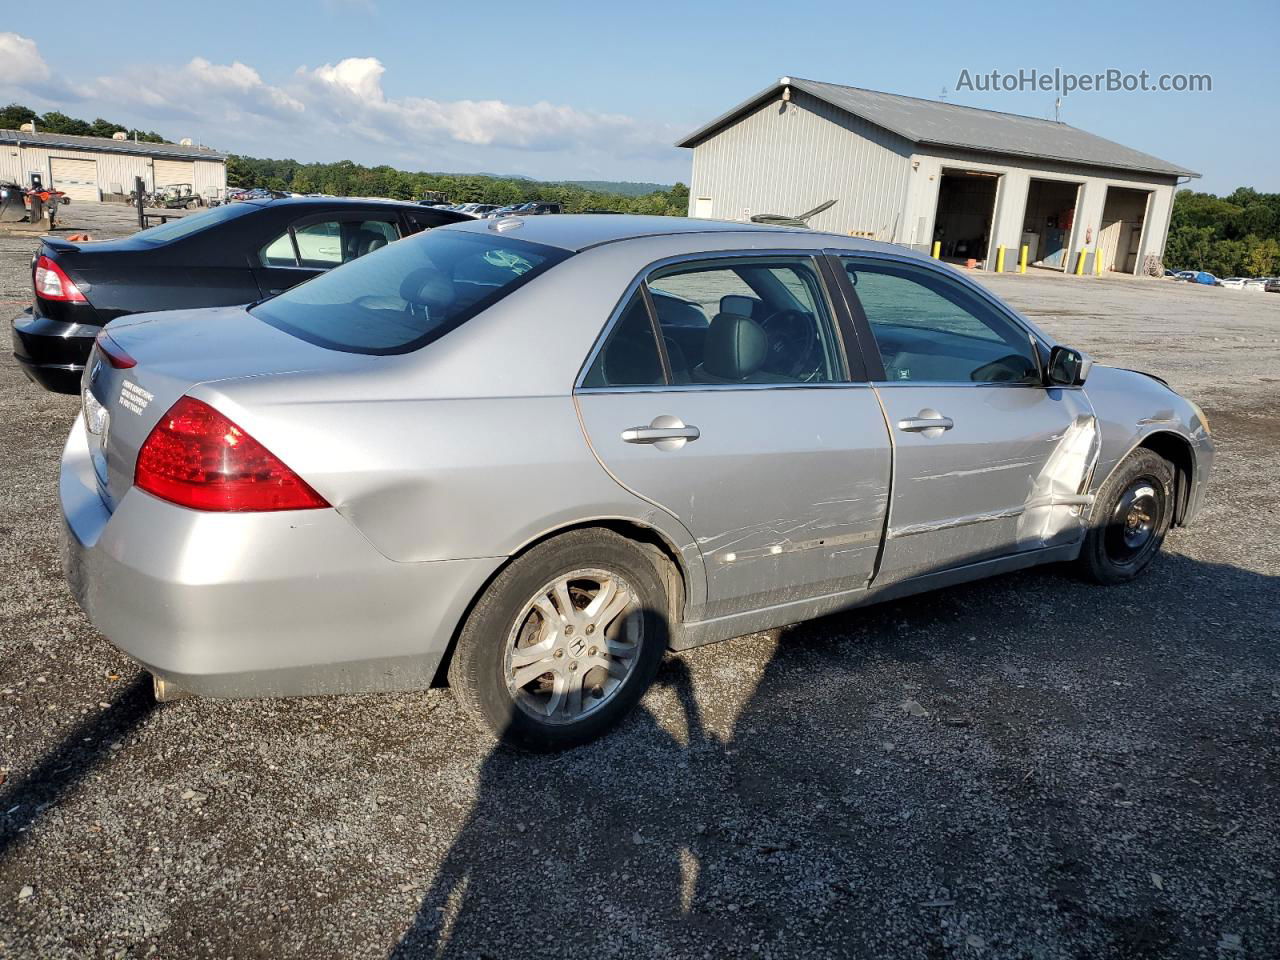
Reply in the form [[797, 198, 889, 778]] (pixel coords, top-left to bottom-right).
[[844, 259, 1041, 384]]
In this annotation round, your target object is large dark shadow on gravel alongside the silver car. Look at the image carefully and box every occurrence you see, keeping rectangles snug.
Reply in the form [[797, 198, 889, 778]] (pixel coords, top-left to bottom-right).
[[390, 554, 1280, 960]]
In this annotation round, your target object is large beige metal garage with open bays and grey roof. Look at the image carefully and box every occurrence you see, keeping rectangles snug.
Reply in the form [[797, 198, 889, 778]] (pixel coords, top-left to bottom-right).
[[677, 77, 1199, 273]]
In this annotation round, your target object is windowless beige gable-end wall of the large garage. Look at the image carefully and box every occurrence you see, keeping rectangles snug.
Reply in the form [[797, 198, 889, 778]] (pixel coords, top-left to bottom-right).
[[689, 90, 911, 242]]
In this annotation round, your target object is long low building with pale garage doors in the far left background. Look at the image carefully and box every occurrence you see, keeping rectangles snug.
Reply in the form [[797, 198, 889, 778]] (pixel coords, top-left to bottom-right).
[[0, 129, 227, 204]]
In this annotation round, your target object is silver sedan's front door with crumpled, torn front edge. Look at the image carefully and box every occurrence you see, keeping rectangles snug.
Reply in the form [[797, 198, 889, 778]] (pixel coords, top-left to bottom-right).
[[845, 257, 1097, 582]]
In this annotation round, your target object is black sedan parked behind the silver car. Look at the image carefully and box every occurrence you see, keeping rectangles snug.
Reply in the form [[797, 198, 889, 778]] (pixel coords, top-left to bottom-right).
[[13, 197, 472, 393]]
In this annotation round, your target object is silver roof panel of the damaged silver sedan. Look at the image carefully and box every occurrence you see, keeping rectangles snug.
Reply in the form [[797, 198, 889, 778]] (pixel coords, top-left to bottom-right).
[[440, 214, 908, 253]]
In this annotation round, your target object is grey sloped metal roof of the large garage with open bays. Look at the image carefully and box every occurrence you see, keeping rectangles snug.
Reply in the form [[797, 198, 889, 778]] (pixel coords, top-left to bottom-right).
[[676, 77, 1199, 177]]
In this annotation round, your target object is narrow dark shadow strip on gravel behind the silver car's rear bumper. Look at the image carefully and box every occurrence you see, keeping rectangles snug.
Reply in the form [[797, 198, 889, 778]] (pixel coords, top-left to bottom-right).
[[0, 673, 156, 858]]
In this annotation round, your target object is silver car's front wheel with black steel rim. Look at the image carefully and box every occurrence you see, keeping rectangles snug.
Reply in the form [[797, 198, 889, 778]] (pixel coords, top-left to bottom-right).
[[1078, 447, 1174, 585]]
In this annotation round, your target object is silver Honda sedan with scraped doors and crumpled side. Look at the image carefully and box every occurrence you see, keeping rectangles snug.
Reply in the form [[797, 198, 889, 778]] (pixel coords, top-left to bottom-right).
[[60, 216, 1213, 749]]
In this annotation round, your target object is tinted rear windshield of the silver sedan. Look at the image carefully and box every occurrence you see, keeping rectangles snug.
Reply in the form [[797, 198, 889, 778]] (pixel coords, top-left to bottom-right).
[[250, 229, 570, 353]]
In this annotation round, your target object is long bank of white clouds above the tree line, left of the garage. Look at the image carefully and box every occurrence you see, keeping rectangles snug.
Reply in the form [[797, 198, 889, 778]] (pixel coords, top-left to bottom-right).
[[0, 33, 687, 179]]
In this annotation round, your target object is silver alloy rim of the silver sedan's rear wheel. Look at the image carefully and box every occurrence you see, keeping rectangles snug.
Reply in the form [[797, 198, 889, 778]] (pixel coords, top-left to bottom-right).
[[504, 568, 644, 723]]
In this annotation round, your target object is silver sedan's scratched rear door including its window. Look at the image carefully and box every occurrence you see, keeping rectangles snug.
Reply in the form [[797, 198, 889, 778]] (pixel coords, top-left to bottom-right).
[[577, 256, 890, 618]]
